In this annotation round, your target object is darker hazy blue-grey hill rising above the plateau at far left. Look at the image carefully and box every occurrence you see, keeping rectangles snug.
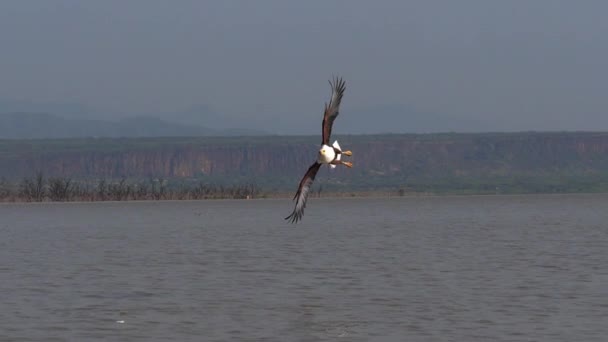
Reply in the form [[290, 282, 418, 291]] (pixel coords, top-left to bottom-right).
[[0, 112, 265, 139]]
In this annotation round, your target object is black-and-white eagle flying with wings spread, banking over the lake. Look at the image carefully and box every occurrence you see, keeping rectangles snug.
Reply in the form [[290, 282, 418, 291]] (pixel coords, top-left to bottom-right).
[[285, 77, 353, 223]]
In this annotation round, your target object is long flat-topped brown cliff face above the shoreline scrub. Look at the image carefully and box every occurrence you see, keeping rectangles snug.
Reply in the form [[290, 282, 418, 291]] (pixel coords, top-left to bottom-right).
[[0, 133, 608, 190]]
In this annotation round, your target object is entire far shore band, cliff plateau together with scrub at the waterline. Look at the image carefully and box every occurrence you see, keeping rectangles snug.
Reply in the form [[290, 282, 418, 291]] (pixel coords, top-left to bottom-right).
[[0, 132, 608, 202]]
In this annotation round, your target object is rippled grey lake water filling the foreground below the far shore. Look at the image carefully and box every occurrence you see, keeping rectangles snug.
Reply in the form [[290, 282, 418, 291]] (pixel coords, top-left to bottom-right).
[[0, 195, 608, 342]]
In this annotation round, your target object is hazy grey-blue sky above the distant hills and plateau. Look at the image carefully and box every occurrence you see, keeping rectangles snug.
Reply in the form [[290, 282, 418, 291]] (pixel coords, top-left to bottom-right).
[[0, 0, 608, 133]]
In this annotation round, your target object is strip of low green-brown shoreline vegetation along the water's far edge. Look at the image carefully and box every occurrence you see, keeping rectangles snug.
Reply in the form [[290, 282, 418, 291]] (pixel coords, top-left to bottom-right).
[[0, 172, 606, 203]]
